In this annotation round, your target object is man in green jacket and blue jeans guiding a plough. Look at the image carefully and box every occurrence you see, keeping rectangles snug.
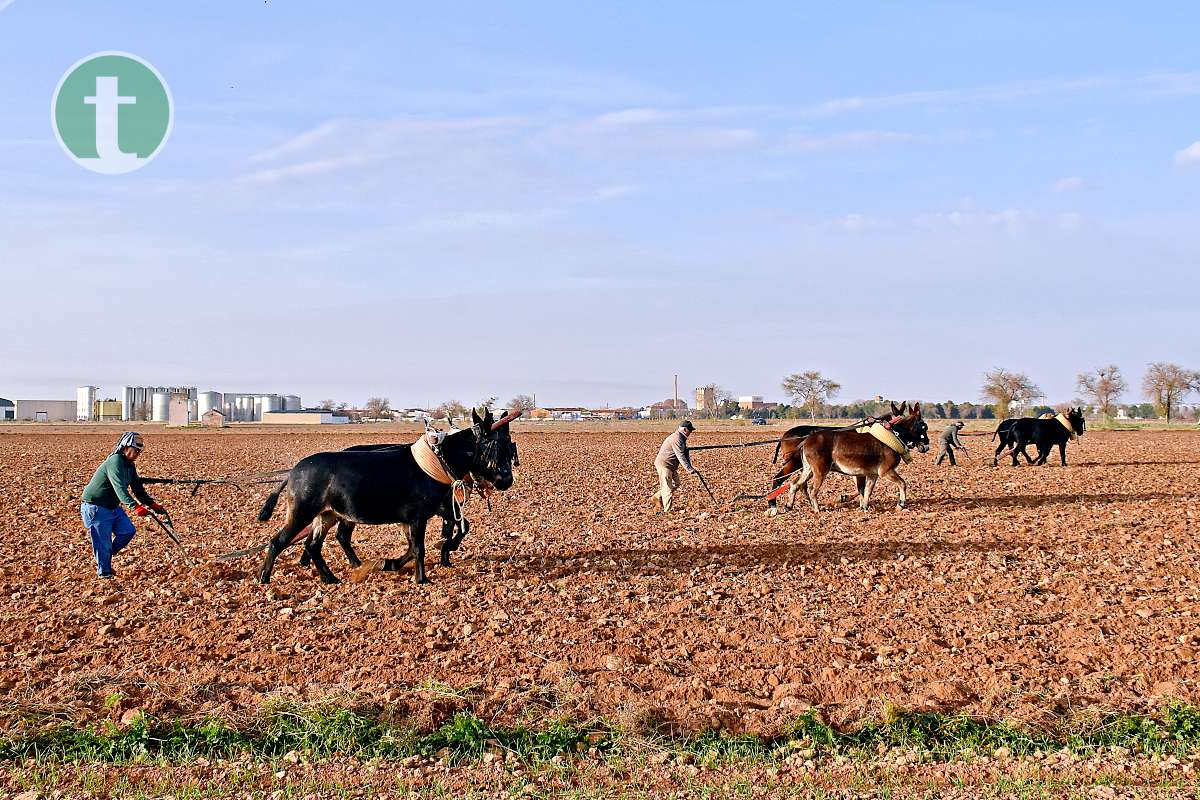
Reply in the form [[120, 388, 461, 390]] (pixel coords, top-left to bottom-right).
[[79, 431, 163, 578]]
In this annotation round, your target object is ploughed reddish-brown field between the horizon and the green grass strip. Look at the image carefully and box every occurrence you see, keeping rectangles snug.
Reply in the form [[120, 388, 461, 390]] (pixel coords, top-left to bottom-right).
[[0, 425, 1200, 733]]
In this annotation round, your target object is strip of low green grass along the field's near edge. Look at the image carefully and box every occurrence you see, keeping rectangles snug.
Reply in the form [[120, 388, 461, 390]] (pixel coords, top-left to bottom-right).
[[7, 704, 1200, 764]]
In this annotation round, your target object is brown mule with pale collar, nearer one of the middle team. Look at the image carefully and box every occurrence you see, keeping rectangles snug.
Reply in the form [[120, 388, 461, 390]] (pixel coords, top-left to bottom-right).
[[787, 403, 929, 511]]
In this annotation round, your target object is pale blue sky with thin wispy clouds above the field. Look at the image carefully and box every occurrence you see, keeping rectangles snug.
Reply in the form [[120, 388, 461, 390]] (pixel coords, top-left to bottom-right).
[[0, 0, 1200, 404]]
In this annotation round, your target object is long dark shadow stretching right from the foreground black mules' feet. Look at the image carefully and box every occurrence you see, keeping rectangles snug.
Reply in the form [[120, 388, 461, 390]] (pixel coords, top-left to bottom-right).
[[481, 540, 1030, 581]]
